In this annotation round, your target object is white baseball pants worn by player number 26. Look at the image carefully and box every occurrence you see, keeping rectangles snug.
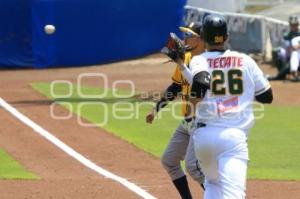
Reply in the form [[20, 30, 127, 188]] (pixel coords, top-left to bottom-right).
[[193, 126, 248, 199]]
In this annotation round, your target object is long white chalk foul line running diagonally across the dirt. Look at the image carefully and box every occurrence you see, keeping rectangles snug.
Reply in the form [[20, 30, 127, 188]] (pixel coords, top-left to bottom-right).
[[0, 98, 156, 199]]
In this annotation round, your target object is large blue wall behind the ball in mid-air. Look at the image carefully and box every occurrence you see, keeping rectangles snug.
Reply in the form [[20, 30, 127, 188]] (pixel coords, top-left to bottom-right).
[[0, 0, 186, 68]]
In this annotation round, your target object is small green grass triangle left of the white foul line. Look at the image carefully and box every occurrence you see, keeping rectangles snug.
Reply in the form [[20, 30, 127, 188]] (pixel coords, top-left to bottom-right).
[[0, 149, 39, 180]]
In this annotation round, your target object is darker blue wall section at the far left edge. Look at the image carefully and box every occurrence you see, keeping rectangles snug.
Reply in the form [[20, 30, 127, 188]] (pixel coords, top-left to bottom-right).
[[0, 0, 34, 67]]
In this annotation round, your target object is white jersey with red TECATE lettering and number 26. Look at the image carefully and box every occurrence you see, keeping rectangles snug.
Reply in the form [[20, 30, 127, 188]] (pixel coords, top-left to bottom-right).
[[190, 50, 270, 130]]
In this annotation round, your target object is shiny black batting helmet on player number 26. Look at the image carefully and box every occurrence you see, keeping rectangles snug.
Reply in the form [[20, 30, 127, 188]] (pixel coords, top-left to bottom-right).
[[201, 14, 228, 45]]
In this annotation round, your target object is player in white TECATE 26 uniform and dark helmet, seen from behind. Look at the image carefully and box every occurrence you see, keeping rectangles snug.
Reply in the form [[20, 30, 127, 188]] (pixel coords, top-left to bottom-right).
[[176, 15, 273, 199]]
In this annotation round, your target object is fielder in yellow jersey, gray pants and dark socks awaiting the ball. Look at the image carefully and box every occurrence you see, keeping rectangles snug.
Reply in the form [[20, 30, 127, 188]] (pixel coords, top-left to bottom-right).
[[146, 23, 205, 199]]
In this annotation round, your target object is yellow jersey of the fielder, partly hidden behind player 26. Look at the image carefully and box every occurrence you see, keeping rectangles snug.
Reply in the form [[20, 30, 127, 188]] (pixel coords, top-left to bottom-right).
[[172, 52, 192, 116]]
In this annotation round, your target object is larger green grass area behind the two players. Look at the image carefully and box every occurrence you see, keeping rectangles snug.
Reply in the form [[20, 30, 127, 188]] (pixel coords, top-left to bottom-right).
[[32, 83, 300, 180]]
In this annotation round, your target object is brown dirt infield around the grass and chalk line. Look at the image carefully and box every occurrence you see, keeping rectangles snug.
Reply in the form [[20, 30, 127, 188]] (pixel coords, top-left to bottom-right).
[[0, 56, 300, 199]]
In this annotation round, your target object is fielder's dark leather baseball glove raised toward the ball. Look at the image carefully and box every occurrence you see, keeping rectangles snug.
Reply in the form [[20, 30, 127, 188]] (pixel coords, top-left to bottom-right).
[[160, 33, 186, 62]]
